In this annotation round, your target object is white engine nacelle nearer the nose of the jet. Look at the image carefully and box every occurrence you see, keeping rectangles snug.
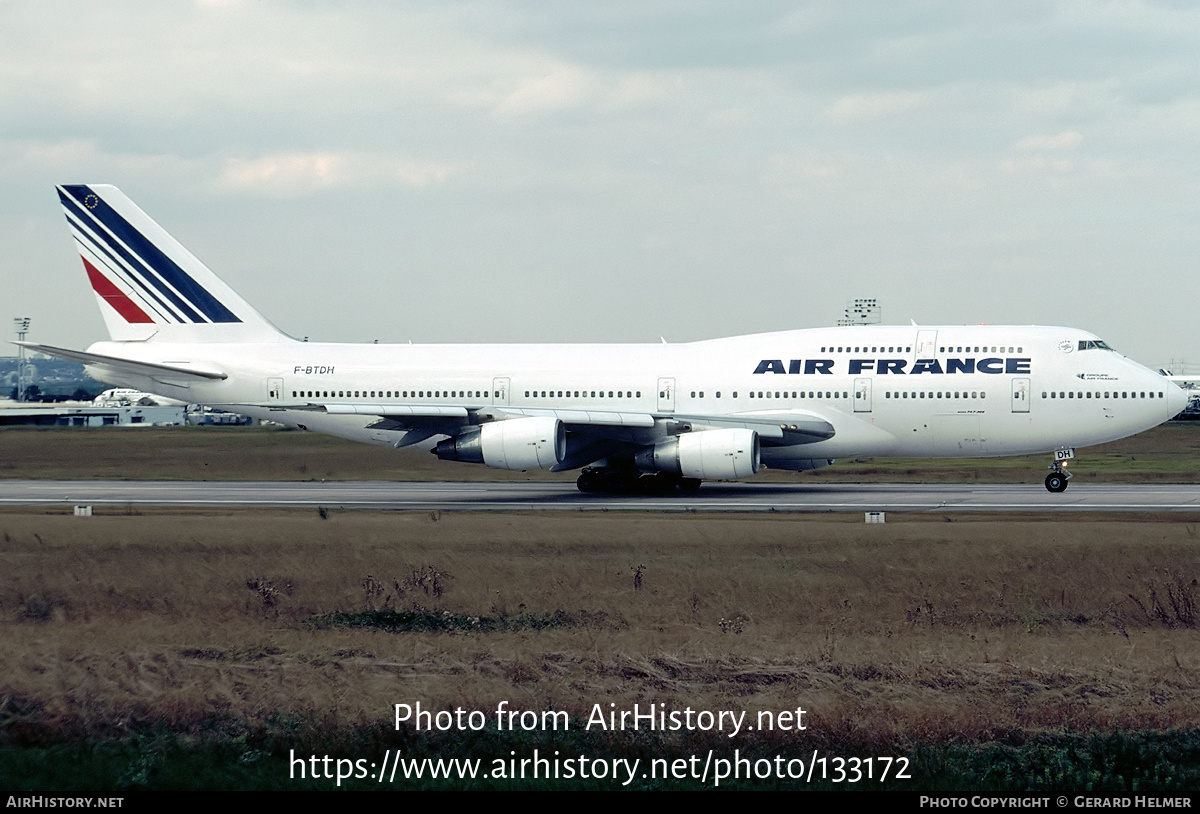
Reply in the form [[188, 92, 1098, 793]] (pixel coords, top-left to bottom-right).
[[634, 429, 760, 480]]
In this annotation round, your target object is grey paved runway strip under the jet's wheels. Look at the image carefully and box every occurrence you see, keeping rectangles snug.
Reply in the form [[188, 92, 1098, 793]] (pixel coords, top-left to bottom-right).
[[0, 480, 1200, 513]]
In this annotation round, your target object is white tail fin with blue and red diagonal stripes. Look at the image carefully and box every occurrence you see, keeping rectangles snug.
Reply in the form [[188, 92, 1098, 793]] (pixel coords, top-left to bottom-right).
[[58, 184, 288, 342]]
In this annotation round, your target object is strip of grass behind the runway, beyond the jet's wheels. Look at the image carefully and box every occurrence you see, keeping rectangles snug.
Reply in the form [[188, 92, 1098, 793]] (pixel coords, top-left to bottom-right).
[[0, 421, 1200, 484]]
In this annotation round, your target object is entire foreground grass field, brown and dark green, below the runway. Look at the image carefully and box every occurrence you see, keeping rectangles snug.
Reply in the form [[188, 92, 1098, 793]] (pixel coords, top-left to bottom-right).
[[0, 509, 1200, 791]]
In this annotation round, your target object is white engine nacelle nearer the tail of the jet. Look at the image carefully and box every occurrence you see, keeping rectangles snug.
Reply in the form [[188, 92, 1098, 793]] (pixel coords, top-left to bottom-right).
[[433, 417, 566, 469]]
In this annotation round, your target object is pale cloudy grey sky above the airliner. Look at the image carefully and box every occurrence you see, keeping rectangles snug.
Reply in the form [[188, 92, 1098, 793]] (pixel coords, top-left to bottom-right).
[[0, 0, 1200, 371]]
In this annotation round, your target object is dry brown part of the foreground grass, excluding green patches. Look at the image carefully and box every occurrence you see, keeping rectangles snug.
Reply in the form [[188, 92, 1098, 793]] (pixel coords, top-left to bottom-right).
[[0, 510, 1200, 743]]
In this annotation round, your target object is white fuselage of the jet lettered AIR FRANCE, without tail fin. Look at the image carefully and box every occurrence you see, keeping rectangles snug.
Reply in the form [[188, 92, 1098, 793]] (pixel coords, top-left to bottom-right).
[[90, 325, 1187, 468]]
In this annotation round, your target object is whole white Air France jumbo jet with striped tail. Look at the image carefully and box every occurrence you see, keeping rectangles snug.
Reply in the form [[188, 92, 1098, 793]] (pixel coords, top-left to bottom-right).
[[26, 185, 1187, 492]]
